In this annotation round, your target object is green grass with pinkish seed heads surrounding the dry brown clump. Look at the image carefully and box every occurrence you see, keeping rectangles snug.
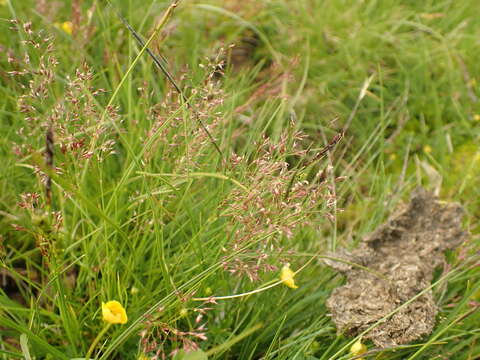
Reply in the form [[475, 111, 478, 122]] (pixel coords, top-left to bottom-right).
[[0, 0, 480, 360]]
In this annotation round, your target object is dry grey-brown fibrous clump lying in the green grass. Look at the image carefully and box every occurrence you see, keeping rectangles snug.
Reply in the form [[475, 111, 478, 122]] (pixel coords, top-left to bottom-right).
[[325, 189, 467, 347]]
